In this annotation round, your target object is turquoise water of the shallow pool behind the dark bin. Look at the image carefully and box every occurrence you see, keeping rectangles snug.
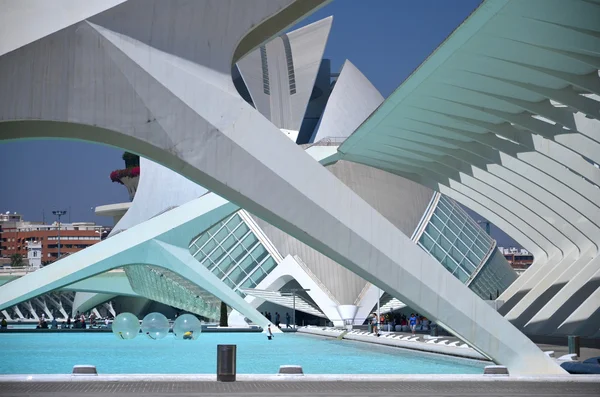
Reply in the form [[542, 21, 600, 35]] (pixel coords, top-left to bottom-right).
[[0, 333, 485, 374]]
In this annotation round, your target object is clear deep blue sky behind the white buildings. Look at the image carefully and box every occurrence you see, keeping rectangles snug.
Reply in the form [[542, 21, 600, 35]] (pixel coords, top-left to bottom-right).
[[0, 0, 508, 245]]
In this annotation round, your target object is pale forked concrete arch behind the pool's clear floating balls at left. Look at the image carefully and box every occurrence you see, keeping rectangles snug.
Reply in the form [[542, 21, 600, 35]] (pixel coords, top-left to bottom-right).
[[0, 194, 267, 327]]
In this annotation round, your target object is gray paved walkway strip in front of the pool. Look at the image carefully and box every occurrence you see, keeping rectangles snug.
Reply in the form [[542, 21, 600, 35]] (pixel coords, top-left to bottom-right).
[[0, 376, 600, 397]]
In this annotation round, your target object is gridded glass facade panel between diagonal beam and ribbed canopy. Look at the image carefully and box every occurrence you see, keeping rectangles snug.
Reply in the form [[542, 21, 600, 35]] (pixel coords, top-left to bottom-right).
[[418, 196, 495, 284]]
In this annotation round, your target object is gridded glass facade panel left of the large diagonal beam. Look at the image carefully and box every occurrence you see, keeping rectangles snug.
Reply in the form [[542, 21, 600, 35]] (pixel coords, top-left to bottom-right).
[[190, 213, 277, 297]]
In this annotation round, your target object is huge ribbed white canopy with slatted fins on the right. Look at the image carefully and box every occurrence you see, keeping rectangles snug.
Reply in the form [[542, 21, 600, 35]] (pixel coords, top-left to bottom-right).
[[339, 0, 600, 336]]
